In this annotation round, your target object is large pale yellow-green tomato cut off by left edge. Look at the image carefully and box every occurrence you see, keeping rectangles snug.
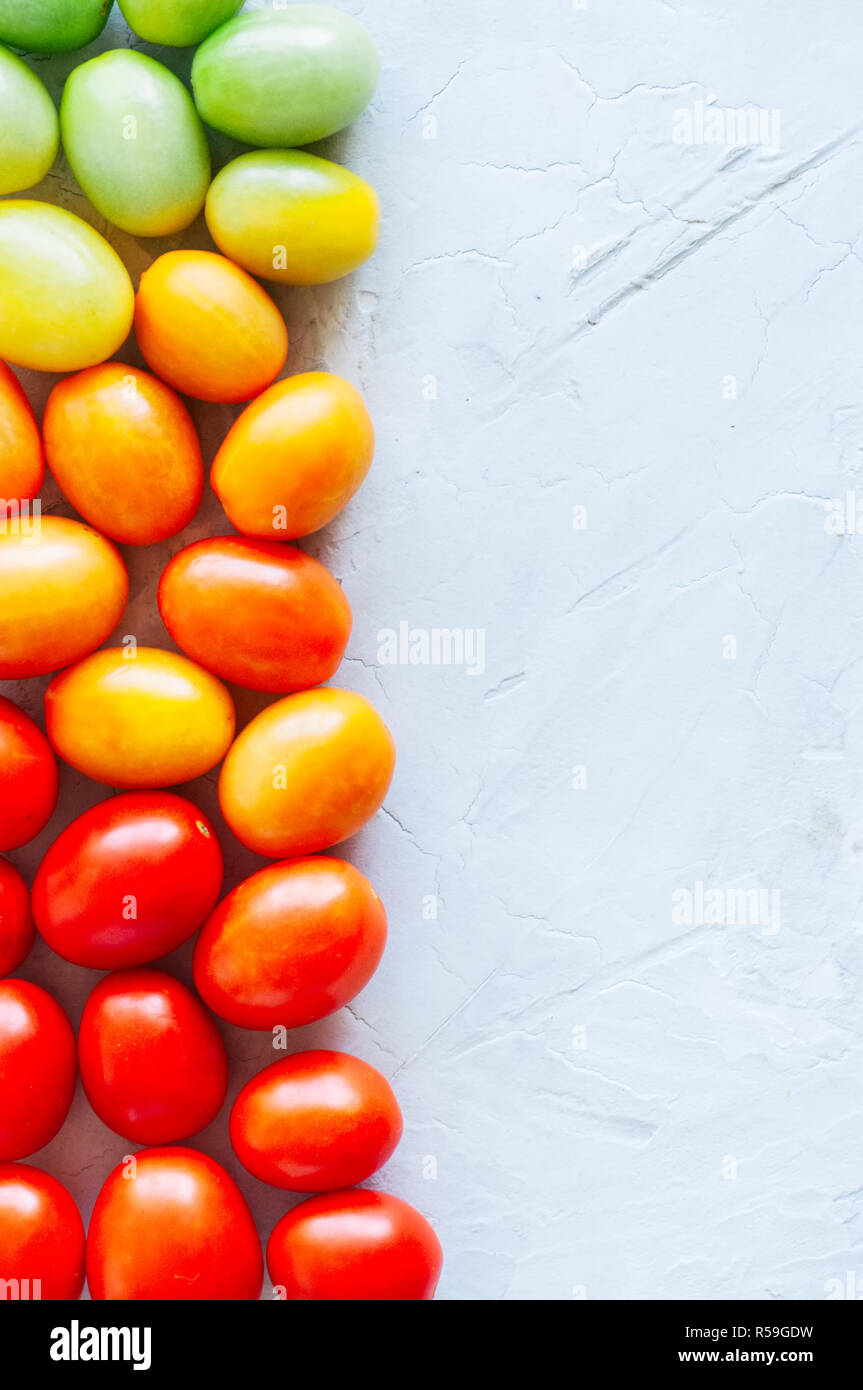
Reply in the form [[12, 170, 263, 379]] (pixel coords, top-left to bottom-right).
[[0, 199, 135, 371]]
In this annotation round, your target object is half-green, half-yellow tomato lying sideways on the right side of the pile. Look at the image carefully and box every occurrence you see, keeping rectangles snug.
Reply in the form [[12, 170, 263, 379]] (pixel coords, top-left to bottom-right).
[[207, 150, 381, 285]]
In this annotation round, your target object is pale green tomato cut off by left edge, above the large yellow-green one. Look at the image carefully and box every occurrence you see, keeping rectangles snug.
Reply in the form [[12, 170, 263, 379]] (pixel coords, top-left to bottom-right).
[[0, 49, 60, 193]]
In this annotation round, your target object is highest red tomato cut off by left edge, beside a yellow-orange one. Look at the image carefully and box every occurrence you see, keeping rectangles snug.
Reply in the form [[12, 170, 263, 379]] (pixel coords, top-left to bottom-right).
[[0, 696, 58, 849]]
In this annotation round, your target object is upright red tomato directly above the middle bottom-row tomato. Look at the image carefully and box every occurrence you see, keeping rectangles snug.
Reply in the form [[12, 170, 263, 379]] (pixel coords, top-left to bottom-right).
[[78, 970, 228, 1144]]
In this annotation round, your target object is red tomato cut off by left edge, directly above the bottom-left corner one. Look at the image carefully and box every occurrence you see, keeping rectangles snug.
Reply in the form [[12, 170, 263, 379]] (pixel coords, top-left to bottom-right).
[[0, 980, 78, 1162]]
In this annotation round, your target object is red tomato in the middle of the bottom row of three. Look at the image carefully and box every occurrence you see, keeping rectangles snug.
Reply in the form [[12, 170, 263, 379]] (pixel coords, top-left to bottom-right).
[[86, 1148, 264, 1301]]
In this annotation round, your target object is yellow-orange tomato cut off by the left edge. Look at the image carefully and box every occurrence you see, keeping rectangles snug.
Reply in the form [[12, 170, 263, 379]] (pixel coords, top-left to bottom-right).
[[0, 517, 129, 680]]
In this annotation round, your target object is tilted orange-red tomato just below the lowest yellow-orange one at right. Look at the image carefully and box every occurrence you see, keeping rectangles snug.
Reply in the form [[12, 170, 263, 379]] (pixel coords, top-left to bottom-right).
[[195, 858, 386, 1029]]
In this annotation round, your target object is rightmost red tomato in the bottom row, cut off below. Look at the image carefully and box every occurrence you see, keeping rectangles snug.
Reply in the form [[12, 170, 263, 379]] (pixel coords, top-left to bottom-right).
[[267, 1188, 443, 1302]]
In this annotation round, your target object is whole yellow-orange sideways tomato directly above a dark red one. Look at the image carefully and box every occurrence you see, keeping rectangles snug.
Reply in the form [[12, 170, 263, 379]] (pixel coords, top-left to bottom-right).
[[44, 646, 233, 788]]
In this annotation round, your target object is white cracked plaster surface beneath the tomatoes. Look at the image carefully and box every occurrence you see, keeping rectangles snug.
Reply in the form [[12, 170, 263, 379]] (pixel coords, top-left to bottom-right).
[[6, 0, 863, 1300]]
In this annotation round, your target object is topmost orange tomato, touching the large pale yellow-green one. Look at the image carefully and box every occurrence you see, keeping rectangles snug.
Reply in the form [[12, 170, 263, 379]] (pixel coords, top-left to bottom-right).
[[135, 252, 288, 402]]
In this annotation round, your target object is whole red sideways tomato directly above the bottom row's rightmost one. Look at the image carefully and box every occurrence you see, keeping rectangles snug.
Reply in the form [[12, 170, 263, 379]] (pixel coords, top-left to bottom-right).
[[231, 1051, 402, 1193]]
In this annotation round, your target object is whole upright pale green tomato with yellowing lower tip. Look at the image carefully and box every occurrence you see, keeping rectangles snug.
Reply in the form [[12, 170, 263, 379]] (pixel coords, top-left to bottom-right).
[[60, 49, 210, 236]]
